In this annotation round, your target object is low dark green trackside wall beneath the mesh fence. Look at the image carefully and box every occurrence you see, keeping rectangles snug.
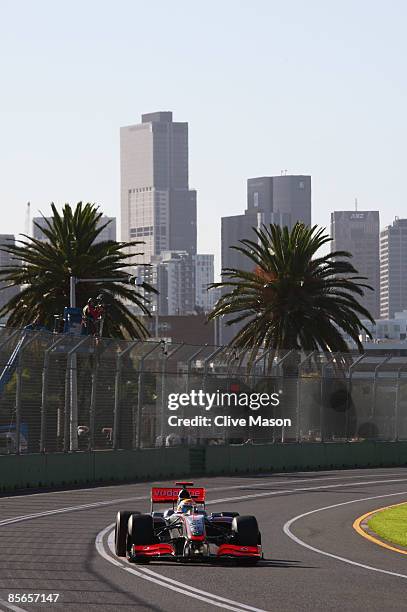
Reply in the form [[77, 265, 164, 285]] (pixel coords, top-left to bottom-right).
[[0, 441, 407, 492]]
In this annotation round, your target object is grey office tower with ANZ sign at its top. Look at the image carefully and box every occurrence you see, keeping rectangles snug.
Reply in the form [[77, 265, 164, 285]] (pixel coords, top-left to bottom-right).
[[331, 210, 380, 318]]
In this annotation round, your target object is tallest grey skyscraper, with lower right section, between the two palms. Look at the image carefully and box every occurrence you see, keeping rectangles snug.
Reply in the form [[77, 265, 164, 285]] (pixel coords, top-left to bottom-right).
[[120, 112, 196, 265]]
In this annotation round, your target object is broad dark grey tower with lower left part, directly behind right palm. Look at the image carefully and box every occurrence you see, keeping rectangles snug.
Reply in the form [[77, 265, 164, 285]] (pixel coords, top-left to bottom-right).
[[221, 175, 311, 270]]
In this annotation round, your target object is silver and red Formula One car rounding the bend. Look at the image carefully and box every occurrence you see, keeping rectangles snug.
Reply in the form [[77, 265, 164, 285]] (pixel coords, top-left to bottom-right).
[[115, 482, 262, 565]]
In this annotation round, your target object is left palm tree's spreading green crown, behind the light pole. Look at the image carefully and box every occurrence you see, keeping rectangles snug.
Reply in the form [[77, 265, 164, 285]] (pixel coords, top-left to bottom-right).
[[0, 202, 156, 338]]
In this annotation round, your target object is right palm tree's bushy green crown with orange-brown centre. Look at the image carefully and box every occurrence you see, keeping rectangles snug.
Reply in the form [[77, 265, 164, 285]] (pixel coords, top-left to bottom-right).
[[209, 223, 374, 363]]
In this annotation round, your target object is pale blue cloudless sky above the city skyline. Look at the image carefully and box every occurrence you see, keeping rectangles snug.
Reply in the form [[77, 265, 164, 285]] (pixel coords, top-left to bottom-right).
[[0, 0, 407, 272]]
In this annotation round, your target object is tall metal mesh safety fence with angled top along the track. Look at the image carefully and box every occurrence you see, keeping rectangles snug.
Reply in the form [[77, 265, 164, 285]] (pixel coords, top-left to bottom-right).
[[0, 328, 407, 454]]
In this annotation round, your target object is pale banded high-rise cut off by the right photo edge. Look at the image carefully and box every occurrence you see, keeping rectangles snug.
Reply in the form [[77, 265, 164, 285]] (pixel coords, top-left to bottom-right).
[[380, 217, 407, 319]]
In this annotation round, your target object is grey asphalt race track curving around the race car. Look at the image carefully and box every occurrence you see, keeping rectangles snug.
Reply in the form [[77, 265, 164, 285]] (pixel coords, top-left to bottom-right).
[[0, 468, 407, 612]]
